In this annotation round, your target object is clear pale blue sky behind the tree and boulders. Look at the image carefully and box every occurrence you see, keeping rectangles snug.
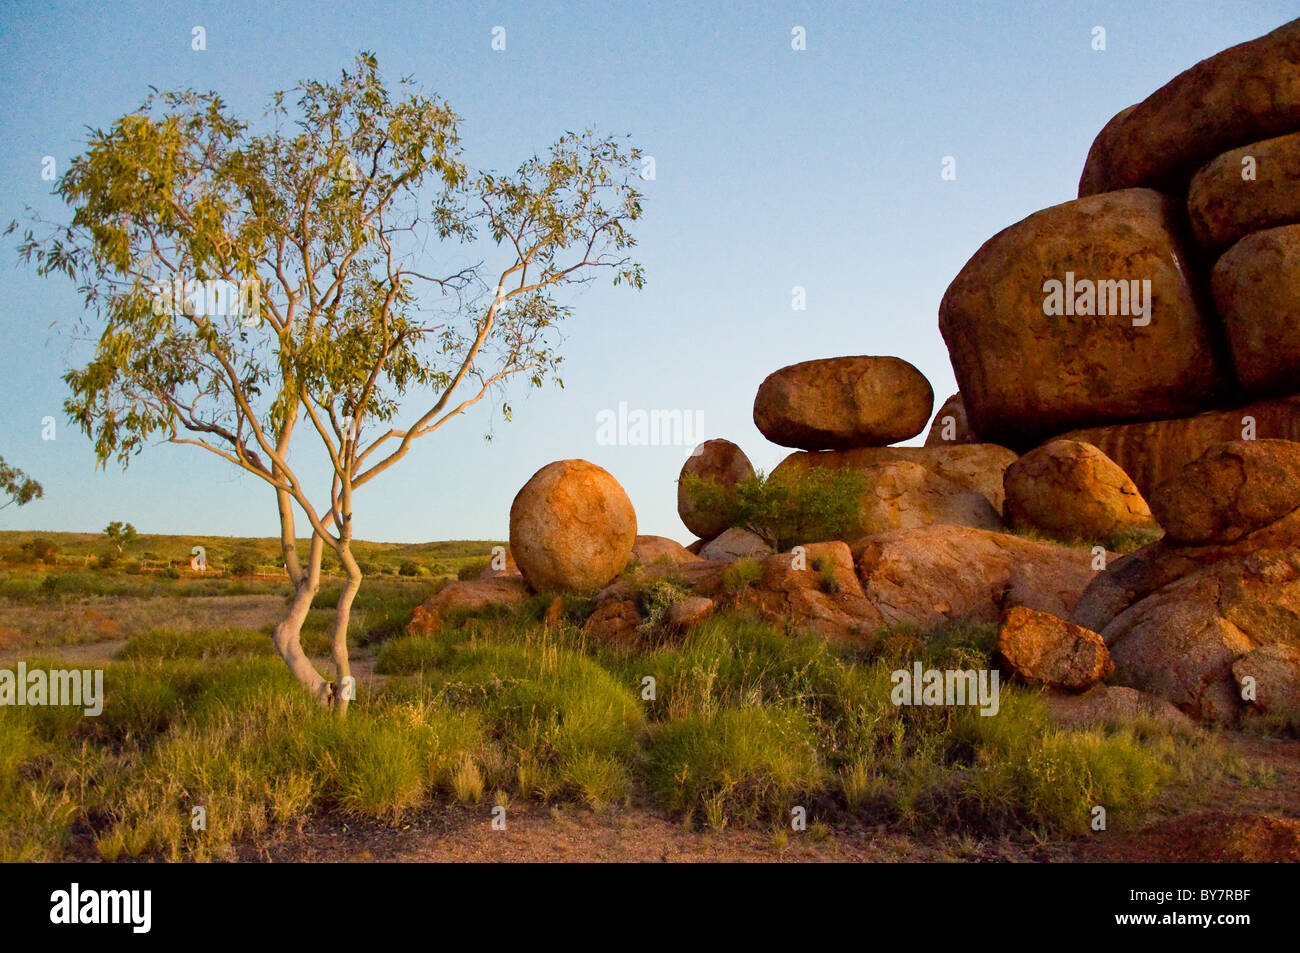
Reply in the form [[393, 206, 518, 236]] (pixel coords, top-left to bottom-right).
[[0, 0, 1296, 542]]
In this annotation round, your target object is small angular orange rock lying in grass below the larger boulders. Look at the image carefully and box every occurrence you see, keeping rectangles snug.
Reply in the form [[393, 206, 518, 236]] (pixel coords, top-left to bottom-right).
[[997, 606, 1114, 692]]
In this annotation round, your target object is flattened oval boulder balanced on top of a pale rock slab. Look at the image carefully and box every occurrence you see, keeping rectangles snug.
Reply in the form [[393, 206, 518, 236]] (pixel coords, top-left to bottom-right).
[[754, 356, 935, 450]]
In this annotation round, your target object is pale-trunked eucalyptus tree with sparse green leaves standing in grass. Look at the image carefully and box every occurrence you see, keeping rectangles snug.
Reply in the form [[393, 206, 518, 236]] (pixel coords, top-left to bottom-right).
[[9, 53, 644, 712]]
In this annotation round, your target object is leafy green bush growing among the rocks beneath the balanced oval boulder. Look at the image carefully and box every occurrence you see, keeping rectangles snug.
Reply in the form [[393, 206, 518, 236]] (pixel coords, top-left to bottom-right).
[[683, 467, 868, 550]]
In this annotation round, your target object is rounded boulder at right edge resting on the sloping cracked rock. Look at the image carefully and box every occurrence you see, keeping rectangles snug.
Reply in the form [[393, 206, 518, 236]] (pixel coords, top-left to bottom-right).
[[1152, 439, 1300, 546]]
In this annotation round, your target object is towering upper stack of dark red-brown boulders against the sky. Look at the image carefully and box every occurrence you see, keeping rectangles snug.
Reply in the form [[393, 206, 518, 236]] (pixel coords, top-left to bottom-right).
[[940, 21, 1300, 495]]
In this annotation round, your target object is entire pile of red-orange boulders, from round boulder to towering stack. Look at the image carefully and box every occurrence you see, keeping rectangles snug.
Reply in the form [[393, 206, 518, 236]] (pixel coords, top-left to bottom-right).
[[412, 21, 1300, 723]]
